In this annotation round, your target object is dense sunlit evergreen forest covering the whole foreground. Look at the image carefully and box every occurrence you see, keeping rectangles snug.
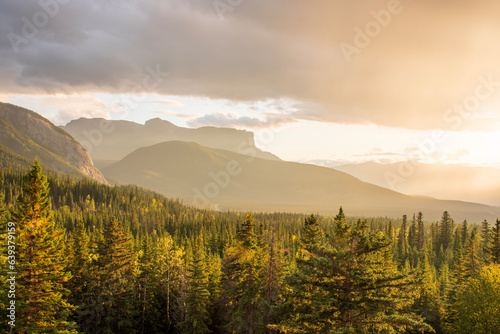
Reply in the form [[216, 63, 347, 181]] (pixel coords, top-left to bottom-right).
[[0, 163, 500, 334]]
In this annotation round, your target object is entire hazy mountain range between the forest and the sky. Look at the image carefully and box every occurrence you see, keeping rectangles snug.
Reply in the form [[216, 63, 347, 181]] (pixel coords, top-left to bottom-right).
[[0, 103, 500, 222]]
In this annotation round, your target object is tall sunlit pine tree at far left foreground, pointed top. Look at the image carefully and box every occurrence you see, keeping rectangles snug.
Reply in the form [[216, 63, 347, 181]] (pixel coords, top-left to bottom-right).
[[14, 160, 74, 334]]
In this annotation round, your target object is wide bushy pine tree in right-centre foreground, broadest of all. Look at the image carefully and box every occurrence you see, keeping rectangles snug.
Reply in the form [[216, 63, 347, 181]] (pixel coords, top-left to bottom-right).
[[272, 207, 430, 333]]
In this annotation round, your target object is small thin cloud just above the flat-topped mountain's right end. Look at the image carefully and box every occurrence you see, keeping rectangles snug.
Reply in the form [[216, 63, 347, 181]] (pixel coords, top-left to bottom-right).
[[187, 112, 296, 129]]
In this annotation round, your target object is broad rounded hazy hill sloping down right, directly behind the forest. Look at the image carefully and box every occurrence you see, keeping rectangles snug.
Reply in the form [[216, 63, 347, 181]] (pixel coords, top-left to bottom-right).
[[102, 141, 500, 221]]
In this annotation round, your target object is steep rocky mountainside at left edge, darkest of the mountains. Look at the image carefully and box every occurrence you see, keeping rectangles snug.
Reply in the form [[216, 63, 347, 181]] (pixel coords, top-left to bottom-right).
[[0, 103, 107, 183]]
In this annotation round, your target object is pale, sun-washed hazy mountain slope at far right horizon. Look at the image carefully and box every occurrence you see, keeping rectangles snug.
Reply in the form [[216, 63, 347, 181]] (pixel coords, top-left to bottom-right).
[[333, 161, 500, 206]]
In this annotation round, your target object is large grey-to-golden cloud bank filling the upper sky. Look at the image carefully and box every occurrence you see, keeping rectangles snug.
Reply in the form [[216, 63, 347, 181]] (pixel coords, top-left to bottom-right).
[[0, 0, 500, 129]]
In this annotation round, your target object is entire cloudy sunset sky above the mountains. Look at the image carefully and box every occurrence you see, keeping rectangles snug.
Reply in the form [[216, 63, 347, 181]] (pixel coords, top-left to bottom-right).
[[0, 0, 500, 168]]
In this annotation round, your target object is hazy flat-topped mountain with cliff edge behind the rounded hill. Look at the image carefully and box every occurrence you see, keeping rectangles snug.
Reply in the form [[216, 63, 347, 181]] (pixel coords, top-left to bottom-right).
[[62, 118, 280, 166]]
